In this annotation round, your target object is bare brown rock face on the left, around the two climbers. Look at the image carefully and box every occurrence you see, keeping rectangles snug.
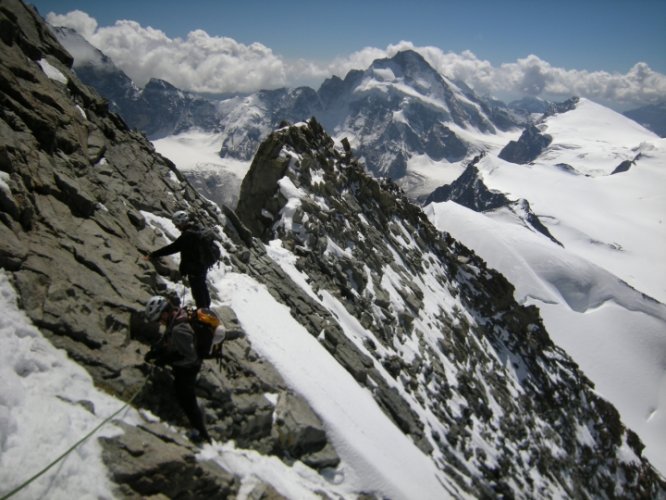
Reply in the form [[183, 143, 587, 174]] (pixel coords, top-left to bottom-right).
[[0, 0, 339, 498]]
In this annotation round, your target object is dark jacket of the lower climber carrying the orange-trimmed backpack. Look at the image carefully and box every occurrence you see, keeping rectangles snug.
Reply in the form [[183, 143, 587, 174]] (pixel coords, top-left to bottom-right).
[[146, 309, 201, 368]]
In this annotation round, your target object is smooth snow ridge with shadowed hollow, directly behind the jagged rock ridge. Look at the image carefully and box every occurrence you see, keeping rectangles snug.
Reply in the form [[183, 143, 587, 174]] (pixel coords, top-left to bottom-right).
[[426, 202, 666, 473]]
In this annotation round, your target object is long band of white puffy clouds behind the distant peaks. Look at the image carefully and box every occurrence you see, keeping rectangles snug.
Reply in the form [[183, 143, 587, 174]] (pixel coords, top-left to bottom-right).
[[47, 11, 666, 106]]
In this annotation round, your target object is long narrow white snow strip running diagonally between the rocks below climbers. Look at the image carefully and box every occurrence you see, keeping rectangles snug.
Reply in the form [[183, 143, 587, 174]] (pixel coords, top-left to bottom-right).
[[208, 268, 450, 499]]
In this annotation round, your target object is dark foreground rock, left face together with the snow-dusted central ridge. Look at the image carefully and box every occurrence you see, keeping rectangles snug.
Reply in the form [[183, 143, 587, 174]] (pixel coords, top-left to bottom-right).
[[0, 0, 666, 498]]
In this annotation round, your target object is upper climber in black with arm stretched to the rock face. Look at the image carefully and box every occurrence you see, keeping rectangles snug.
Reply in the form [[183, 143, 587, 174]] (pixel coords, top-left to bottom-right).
[[146, 210, 210, 308]]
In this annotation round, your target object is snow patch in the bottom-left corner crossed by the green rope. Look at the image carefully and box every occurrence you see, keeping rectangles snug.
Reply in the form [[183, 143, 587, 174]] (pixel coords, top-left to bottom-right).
[[0, 269, 127, 500]]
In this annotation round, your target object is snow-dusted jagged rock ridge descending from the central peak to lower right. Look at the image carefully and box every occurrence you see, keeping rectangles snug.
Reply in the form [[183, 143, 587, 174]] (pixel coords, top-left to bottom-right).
[[233, 119, 664, 498]]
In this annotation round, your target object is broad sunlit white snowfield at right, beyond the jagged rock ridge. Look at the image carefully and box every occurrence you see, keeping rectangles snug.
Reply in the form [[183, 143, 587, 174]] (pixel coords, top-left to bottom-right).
[[426, 99, 666, 474]]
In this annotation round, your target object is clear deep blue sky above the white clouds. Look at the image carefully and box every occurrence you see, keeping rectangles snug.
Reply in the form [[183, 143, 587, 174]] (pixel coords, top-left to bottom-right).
[[32, 0, 666, 73]]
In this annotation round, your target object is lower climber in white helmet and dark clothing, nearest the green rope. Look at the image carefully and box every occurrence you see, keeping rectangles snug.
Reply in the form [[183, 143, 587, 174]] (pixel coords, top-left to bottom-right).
[[145, 295, 211, 443]]
